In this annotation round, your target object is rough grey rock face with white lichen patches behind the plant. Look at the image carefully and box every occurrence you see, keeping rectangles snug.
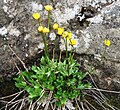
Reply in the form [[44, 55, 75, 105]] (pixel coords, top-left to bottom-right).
[[0, 0, 120, 93]]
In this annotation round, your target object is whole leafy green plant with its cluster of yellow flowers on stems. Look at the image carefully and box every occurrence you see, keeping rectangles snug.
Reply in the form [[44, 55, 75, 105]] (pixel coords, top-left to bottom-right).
[[15, 5, 91, 106]]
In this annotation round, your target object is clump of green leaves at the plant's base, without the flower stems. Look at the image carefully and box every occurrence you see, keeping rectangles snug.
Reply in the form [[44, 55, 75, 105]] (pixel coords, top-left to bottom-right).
[[15, 57, 90, 105]]
